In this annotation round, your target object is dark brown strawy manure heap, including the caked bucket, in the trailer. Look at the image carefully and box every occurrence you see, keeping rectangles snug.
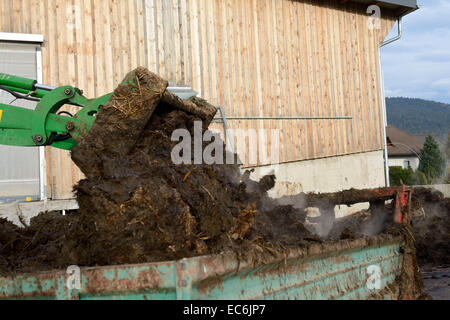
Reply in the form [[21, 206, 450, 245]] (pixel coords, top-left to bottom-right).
[[0, 68, 320, 273]]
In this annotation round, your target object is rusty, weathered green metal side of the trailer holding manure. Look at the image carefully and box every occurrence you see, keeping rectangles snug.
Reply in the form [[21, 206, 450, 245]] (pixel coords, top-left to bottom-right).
[[0, 235, 409, 300]]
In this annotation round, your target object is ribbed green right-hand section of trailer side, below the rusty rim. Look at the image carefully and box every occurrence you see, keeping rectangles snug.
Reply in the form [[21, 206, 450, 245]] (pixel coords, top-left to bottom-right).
[[192, 244, 401, 299]]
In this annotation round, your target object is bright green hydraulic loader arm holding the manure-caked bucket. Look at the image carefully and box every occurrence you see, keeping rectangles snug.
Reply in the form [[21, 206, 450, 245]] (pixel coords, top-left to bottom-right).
[[0, 73, 112, 150]]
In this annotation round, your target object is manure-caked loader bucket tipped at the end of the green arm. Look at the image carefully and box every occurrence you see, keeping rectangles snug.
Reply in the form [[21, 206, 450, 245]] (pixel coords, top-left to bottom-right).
[[72, 67, 217, 176]]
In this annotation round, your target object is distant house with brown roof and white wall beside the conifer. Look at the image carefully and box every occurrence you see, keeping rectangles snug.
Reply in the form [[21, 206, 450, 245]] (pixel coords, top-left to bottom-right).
[[386, 126, 423, 170]]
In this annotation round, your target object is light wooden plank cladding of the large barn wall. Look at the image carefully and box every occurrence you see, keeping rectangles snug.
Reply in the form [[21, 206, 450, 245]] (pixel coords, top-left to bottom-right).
[[0, 0, 395, 199]]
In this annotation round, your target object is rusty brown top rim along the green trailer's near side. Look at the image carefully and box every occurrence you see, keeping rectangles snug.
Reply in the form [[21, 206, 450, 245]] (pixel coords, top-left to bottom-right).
[[0, 234, 403, 299]]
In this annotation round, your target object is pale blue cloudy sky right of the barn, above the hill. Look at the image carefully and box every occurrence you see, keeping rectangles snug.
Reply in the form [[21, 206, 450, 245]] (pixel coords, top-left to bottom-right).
[[381, 0, 450, 104]]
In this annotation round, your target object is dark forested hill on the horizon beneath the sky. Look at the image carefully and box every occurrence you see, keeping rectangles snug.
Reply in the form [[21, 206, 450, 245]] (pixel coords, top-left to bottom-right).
[[386, 97, 450, 138]]
